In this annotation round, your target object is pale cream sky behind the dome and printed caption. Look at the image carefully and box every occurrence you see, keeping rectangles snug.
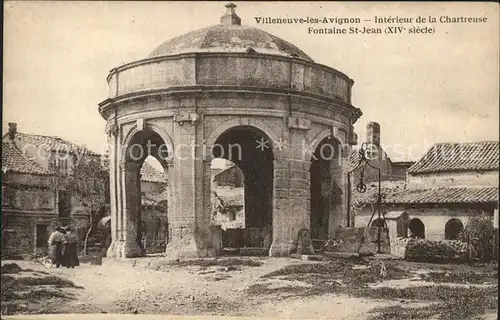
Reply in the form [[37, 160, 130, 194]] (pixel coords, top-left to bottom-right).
[[2, 1, 499, 161]]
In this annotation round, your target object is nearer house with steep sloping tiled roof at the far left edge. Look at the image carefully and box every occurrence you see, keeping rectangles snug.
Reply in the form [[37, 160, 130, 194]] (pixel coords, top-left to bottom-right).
[[2, 142, 59, 256]]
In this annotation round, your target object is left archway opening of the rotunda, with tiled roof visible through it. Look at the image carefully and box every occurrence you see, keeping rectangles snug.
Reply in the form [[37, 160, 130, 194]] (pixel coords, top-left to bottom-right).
[[124, 129, 170, 255]]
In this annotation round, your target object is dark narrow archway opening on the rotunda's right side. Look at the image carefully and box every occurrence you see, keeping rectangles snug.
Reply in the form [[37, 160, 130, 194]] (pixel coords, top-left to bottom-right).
[[309, 136, 342, 240]]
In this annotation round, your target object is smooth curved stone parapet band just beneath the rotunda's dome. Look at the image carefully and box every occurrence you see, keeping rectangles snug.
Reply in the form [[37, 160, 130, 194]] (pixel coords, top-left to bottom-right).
[[108, 53, 352, 103]]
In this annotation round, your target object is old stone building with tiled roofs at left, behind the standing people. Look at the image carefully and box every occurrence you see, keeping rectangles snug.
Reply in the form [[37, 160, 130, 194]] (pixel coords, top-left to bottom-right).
[[2, 123, 102, 255]]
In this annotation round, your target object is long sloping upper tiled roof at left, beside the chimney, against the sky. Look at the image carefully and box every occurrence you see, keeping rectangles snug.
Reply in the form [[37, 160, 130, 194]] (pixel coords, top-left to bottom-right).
[[5, 132, 97, 155]]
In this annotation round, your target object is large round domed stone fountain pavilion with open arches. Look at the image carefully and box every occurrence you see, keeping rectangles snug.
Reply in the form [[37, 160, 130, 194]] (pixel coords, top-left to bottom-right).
[[99, 4, 361, 257]]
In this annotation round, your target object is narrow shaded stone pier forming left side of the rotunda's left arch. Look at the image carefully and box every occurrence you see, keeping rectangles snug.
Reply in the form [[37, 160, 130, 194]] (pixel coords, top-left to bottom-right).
[[121, 162, 143, 258]]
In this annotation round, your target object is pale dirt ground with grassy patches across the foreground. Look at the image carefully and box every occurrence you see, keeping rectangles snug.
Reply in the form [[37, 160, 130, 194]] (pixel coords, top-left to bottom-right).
[[2, 257, 498, 320]]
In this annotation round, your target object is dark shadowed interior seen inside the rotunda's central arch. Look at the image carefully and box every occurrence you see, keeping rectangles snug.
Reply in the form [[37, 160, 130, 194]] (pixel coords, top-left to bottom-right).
[[212, 126, 274, 254]]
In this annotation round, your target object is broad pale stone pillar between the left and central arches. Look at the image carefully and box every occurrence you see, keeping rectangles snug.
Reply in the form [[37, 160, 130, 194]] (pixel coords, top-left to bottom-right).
[[166, 116, 214, 259]]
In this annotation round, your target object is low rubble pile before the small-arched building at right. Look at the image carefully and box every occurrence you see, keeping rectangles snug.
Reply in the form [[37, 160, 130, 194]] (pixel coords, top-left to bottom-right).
[[404, 239, 467, 262]]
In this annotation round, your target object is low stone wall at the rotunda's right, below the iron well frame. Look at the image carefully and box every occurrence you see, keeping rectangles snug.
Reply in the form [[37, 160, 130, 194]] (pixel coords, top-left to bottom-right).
[[325, 227, 391, 253]]
